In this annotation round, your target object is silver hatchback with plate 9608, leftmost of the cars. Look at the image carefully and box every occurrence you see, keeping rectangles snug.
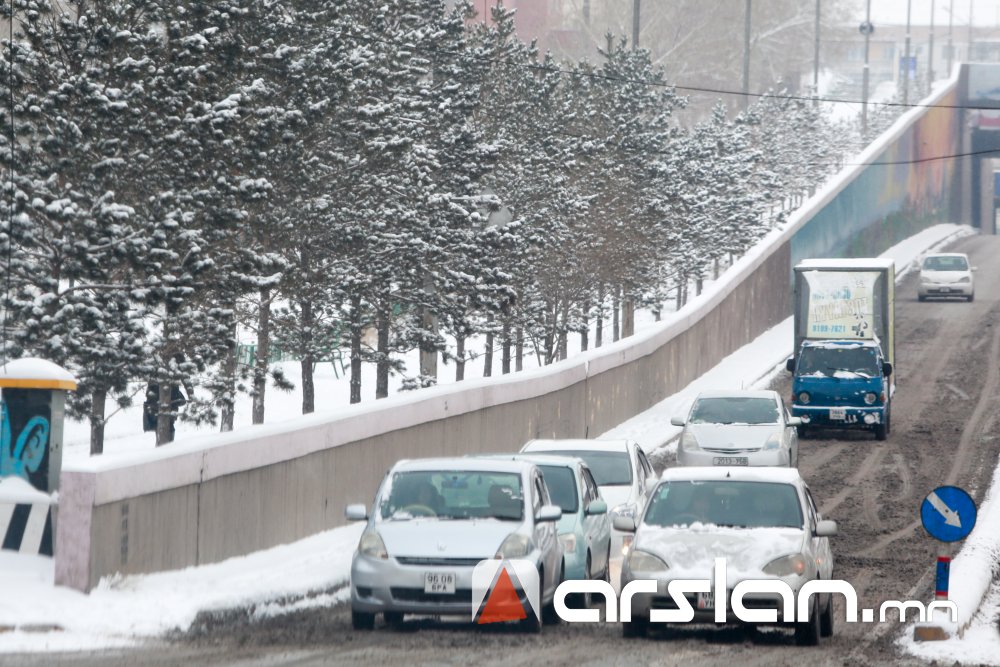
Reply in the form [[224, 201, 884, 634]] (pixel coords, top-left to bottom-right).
[[345, 458, 563, 631]]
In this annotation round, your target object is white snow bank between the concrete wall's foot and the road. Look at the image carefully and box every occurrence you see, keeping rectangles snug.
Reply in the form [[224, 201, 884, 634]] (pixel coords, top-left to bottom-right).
[[0, 225, 976, 657]]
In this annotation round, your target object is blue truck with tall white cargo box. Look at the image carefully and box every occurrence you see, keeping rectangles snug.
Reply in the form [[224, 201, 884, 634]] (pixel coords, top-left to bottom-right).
[[786, 258, 895, 440]]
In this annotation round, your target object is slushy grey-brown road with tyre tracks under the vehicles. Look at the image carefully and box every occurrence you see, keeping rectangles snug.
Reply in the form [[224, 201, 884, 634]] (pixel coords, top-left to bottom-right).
[[4, 237, 1000, 666]]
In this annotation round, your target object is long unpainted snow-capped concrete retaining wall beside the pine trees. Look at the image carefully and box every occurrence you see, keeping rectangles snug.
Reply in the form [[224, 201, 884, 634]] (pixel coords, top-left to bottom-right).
[[56, 74, 968, 590]]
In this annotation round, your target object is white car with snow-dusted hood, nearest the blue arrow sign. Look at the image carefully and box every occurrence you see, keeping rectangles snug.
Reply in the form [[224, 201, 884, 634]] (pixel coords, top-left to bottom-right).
[[616, 468, 837, 645]]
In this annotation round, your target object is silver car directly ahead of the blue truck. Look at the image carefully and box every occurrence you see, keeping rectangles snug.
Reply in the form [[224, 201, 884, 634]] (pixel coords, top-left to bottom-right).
[[670, 390, 801, 468]]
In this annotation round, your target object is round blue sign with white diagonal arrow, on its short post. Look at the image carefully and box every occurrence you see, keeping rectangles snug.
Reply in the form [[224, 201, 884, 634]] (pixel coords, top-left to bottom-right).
[[913, 486, 976, 641]]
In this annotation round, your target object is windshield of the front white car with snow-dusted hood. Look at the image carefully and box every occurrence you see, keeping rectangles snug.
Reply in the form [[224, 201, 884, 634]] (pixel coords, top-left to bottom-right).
[[644, 480, 802, 528]]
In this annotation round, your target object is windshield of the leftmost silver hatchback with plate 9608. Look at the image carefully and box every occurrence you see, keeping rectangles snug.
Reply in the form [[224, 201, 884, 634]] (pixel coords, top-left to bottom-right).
[[380, 470, 524, 521]]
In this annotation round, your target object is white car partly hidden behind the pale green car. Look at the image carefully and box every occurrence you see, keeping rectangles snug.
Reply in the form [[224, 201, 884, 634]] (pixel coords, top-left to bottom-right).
[[521, 439, 656, 558]]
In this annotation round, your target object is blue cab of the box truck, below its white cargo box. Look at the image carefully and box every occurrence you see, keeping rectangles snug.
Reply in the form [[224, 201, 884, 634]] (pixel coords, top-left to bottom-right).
[[787, 339, 892, 440]]
